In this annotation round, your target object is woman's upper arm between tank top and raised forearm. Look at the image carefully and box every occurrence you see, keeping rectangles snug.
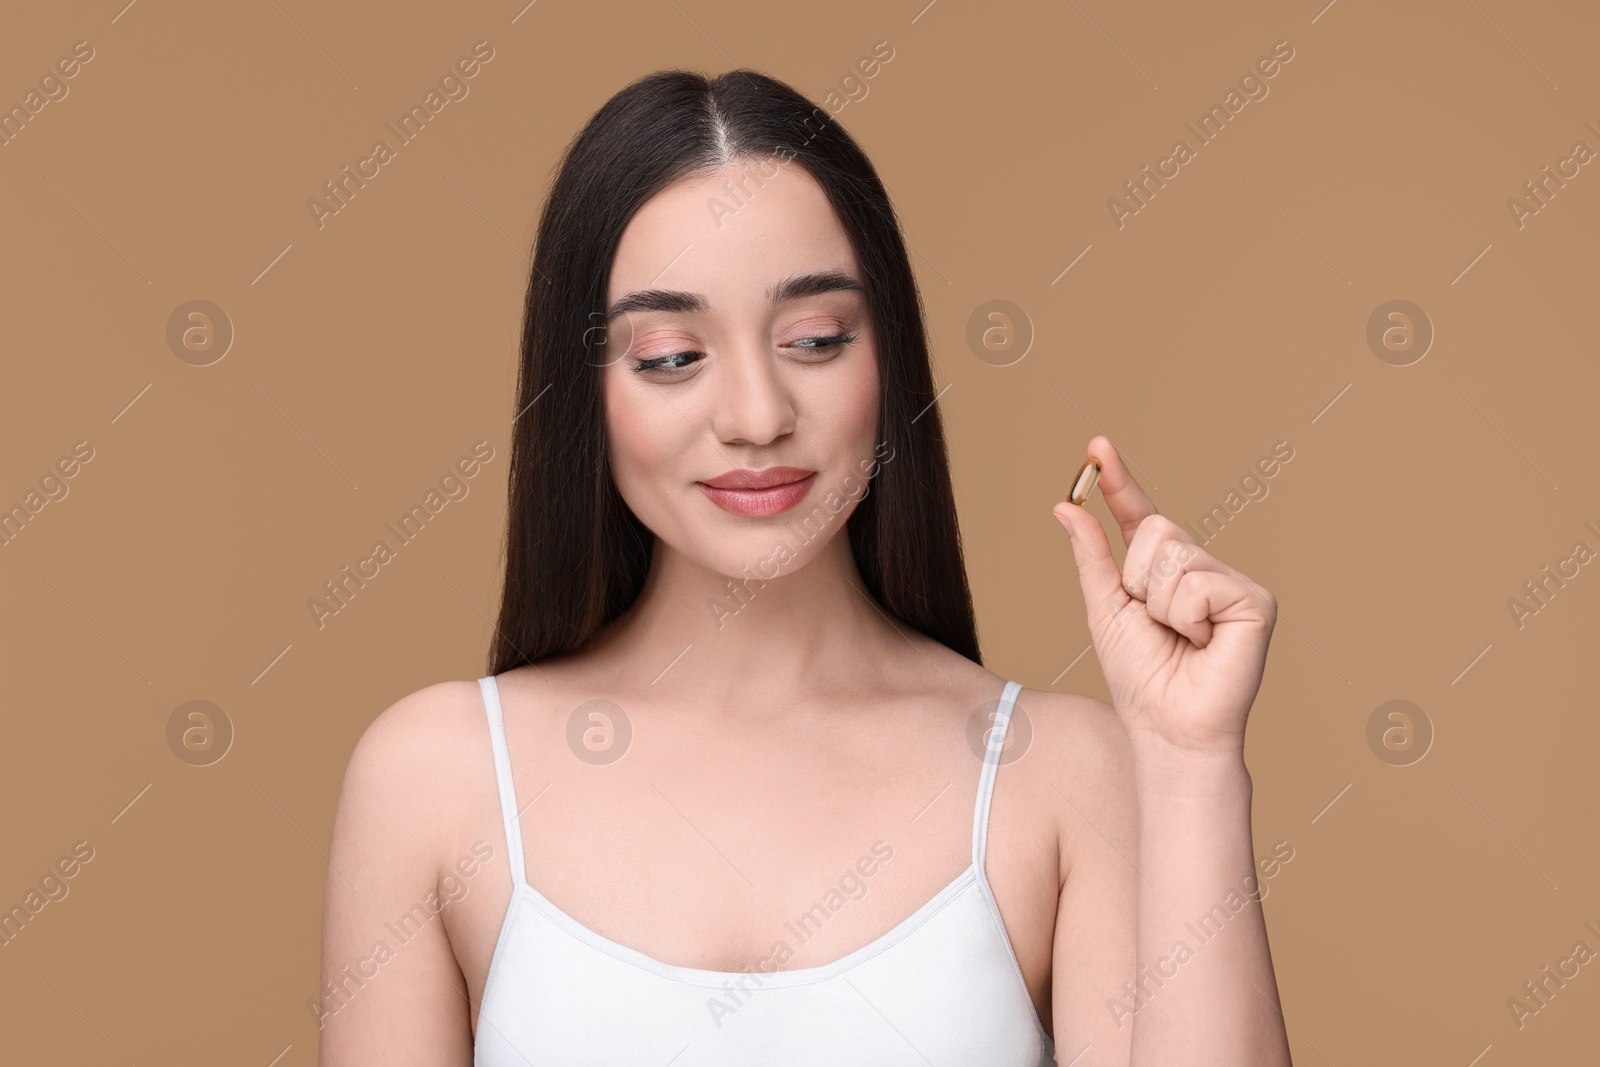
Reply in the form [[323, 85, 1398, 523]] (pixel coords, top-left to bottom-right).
[[1051, 694, 1142, 1067]]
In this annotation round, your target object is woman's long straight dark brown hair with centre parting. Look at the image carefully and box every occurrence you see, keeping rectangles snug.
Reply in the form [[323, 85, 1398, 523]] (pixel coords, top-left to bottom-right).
[[490, 70, 982, 673]]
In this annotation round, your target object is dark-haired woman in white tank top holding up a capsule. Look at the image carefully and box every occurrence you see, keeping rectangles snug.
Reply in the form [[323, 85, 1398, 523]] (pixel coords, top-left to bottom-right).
[[317, 70, 1288, 1067]]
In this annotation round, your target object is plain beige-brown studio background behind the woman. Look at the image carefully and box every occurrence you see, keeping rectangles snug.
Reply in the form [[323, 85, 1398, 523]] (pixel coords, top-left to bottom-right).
[[0, 0, 1600, 1067]]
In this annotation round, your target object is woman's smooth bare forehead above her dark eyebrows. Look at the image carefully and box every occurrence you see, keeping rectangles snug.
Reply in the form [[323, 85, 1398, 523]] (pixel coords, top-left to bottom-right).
[[606, 160, 859, 309]]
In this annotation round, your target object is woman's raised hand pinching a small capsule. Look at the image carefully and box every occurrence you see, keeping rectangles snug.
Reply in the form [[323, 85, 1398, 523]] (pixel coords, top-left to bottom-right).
[[1051, 435, 1278, 755]]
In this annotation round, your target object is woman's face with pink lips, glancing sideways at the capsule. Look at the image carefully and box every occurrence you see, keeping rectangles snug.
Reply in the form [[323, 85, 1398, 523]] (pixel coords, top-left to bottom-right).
[[602, 154, 878, 577]]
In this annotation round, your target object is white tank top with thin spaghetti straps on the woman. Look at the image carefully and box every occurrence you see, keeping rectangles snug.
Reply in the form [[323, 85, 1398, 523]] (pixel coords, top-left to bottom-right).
[[474, 677, 1054, 1067]]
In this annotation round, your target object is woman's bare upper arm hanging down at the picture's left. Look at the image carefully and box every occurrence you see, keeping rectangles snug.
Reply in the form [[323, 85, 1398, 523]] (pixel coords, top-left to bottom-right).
[[317, 681, 475, 1067]]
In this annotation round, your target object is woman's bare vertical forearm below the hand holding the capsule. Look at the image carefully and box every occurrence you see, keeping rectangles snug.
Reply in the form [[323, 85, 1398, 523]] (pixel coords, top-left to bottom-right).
[[1120, 736, 1290, 1067]]
